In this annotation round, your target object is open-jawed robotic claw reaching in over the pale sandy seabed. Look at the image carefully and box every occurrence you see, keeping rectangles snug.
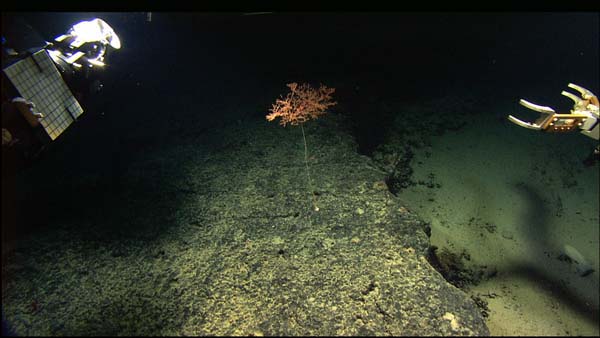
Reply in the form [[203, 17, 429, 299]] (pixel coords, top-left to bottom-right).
[[508, 83, 600, 155]]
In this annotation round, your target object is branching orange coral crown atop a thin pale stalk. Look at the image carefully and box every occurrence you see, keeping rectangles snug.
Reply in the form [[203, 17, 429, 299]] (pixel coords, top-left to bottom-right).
[[266, 82, 337, 127]]
